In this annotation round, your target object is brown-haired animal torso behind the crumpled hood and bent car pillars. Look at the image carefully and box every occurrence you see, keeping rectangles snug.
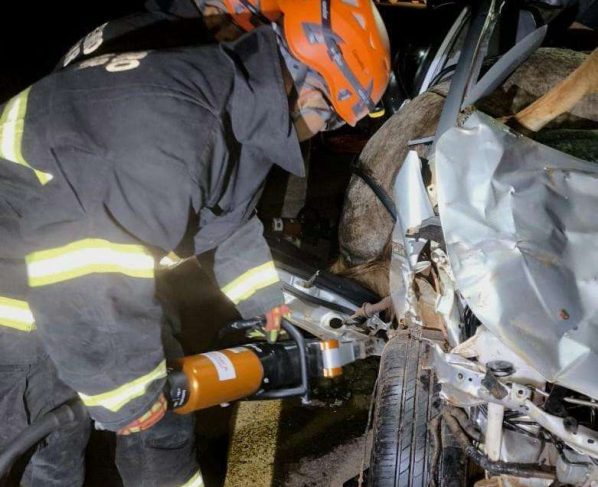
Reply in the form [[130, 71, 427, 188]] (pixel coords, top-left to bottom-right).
[[333, 48, 598, 296]]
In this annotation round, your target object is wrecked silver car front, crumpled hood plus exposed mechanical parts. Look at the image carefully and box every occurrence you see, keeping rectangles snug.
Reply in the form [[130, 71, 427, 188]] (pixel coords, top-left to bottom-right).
[[382, 108, 598, 486]]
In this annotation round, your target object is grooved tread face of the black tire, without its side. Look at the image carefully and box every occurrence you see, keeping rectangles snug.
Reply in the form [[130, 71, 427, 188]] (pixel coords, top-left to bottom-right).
[[368, 334, 434, 487]]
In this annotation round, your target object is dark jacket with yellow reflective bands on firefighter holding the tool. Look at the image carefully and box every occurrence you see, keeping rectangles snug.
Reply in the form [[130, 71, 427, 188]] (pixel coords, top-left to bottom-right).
[[0, 27, 303, 486]]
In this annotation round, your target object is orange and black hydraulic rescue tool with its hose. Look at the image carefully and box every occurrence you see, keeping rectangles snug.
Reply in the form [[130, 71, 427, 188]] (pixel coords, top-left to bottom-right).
[[0, 318, 344, 478]]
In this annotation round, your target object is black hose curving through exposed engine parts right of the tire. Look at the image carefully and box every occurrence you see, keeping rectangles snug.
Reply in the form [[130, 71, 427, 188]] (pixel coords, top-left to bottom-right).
[[442, 409, 556, 479]]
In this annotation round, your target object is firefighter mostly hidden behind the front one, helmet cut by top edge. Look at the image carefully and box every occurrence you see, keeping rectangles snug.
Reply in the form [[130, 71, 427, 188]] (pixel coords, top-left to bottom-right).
[[0, 0, 280, 485]]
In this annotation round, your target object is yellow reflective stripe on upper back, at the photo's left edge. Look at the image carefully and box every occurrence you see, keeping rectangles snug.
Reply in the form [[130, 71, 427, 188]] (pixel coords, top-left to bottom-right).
[[0, 88, 53, 184]]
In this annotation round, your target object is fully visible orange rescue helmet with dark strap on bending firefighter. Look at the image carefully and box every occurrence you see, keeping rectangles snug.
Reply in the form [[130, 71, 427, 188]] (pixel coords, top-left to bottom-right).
[[278, 0, 390, 125]]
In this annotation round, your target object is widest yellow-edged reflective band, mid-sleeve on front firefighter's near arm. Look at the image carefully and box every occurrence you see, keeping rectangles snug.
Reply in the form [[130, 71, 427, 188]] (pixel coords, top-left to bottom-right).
[[25, 238, 154, 287]]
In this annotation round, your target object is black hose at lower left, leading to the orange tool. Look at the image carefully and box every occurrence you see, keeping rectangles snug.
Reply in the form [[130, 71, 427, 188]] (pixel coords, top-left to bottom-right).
[[0, 400, 87, 478]]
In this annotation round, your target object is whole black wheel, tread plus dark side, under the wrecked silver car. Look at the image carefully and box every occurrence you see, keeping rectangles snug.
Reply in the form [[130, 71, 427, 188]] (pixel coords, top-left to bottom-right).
[[367, 333, 470, 487]]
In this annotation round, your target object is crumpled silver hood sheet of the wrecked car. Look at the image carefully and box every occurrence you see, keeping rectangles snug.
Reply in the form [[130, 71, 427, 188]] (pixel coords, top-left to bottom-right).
[[435, 113, 598, 398]]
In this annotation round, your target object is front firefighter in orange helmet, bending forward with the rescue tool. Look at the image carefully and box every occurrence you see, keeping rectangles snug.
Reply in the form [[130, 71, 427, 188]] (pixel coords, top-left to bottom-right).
[[0, 0, 390, 487]]
